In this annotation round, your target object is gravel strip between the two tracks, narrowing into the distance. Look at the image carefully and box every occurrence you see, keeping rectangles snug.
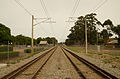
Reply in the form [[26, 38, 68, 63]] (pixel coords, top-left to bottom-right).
[[36, 47, 81, 79]]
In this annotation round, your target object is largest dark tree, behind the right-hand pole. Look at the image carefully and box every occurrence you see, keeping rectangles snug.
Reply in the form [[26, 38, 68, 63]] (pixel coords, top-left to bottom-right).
[[66, 13, 102, 45]]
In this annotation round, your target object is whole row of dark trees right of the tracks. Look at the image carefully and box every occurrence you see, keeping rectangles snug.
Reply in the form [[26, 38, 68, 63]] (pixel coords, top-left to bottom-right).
[[65, 13, 120, 45]]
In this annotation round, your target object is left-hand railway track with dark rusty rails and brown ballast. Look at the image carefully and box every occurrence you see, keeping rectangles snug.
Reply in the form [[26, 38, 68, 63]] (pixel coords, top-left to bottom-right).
[[1, 47, 57, 79]]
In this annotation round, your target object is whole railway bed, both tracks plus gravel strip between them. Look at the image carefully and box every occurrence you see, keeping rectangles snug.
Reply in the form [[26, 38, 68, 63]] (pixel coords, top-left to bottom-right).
[[2, 46, 117, 79]]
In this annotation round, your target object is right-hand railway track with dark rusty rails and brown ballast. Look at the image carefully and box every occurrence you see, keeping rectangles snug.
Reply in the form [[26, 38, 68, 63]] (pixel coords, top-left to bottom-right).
[[61, 47, 118, 79]]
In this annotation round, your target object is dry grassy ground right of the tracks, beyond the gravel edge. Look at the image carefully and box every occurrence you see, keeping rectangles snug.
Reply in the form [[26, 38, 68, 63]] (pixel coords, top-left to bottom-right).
[[67, 46, 120, 69]]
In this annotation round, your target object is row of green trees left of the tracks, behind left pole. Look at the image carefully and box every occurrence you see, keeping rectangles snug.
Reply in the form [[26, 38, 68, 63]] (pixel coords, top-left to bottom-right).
[[0, 23, 58, 45]]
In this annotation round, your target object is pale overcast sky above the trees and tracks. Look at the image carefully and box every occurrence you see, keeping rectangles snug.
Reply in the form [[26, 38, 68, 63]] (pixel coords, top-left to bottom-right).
[[0, 0, 120, 42]]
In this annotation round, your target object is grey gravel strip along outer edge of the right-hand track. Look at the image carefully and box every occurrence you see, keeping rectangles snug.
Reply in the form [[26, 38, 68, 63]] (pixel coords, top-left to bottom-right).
[[66, 48, 120, 78]]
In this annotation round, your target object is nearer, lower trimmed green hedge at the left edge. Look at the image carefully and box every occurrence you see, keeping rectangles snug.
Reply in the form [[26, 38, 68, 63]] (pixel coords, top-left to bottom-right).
[[0, 52, 19, 59]]
